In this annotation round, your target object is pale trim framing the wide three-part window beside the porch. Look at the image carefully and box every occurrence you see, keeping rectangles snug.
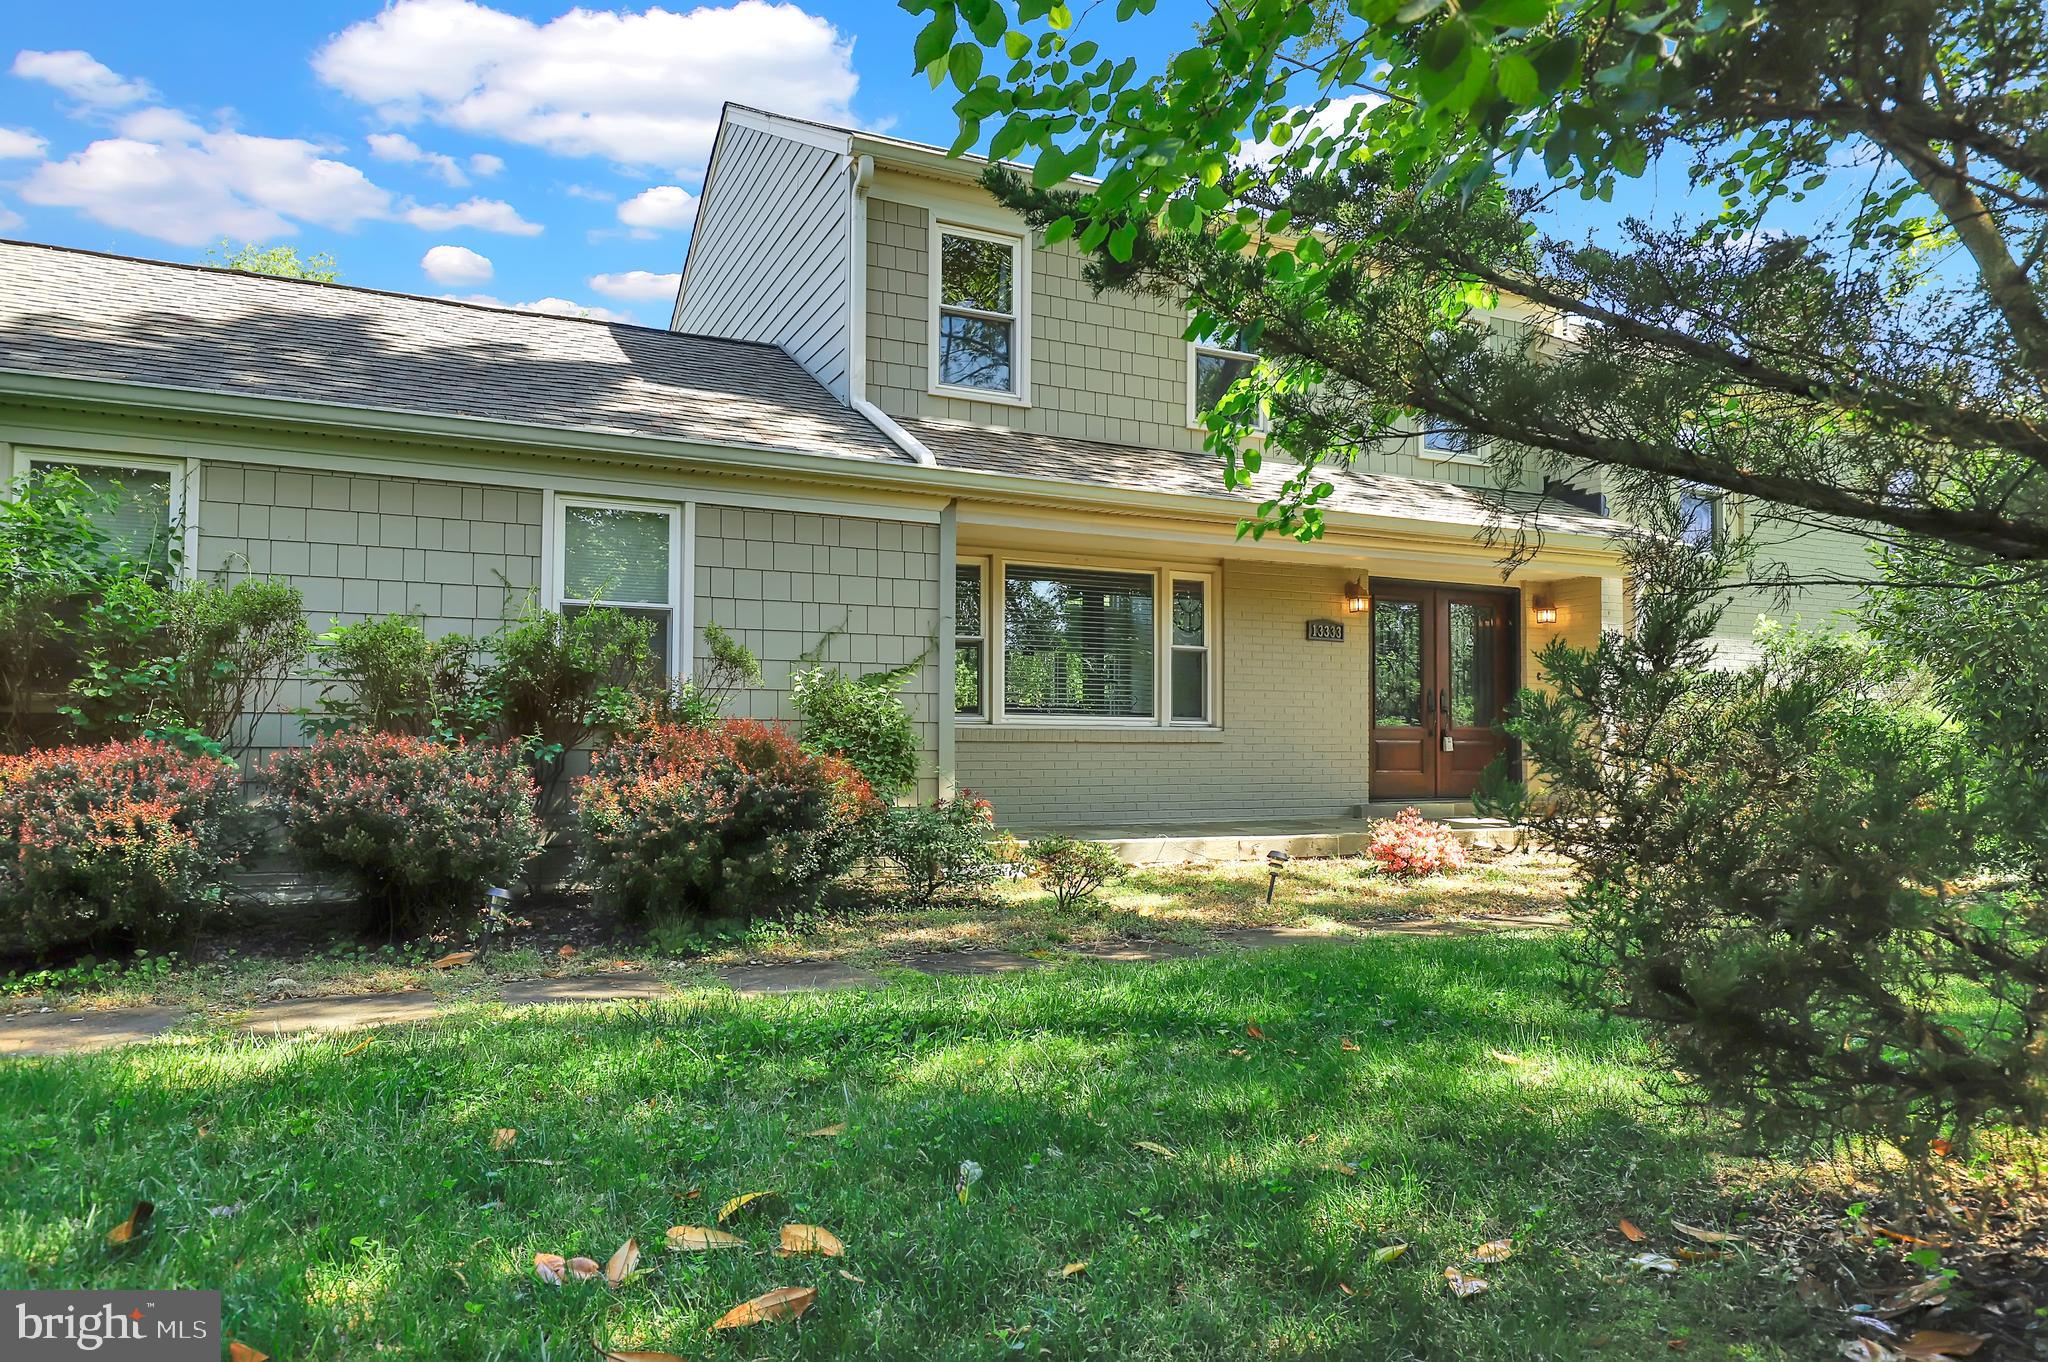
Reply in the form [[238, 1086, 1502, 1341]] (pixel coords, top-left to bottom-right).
[[970, 553, 1223, 733]]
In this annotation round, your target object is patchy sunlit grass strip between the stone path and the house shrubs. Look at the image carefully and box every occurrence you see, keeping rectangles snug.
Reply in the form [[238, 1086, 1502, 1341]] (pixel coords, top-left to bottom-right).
[[0, 852, 1569, 1014]]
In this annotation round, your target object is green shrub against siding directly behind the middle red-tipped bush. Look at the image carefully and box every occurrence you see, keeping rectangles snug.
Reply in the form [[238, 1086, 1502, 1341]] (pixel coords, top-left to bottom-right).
[[303, 614, 496, 739]]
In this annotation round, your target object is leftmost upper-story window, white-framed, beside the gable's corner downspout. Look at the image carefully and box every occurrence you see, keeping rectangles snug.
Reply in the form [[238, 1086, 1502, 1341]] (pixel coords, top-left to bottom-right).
[[932, 223, 1028, 401]]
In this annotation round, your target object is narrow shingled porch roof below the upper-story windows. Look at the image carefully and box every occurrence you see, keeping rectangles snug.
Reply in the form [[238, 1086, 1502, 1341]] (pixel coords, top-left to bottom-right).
[[903, 420, 1622, 535]]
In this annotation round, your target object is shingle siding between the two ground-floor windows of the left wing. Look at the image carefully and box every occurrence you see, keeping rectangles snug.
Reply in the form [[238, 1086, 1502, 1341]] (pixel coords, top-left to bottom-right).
[[199, 463, 541, 750]]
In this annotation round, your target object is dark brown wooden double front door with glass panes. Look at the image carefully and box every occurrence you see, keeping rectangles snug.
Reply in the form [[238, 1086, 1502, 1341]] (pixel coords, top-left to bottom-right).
[[1370, 582, 1518, 799]]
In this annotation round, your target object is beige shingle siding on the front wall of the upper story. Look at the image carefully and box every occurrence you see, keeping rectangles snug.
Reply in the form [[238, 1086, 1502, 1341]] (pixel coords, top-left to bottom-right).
[[866, 197, 1536, 487]]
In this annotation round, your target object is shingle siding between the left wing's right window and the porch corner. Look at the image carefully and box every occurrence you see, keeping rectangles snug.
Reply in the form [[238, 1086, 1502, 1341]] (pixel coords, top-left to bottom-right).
[[696, 506, 950, 799]]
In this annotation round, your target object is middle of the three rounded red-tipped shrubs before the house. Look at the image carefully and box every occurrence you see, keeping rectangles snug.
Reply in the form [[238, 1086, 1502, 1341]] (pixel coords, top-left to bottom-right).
[[272, 733, 541, 932]]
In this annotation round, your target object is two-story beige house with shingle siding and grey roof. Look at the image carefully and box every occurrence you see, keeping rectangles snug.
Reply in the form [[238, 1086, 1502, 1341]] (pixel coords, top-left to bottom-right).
[[0, 107, 1875, 825]]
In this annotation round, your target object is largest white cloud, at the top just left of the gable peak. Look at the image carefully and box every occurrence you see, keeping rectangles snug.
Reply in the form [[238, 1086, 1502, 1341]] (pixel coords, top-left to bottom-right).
[[313, 0, 860, 172]]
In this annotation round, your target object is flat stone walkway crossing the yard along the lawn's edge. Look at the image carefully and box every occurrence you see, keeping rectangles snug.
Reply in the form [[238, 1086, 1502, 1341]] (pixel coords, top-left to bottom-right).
[[0, 913, 1565, 1059]]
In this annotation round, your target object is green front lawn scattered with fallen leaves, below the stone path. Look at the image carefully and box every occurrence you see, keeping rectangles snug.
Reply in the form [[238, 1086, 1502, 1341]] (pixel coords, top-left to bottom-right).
[[0, 938, 1833, 1362]]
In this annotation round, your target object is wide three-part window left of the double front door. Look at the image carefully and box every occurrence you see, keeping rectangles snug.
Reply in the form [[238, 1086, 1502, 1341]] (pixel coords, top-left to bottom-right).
[[954, 559, 1217, 727]]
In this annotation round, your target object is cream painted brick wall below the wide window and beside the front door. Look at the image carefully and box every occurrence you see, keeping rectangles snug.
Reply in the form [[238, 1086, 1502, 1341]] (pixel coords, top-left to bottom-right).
[[954, 561, 1368, 827]]
